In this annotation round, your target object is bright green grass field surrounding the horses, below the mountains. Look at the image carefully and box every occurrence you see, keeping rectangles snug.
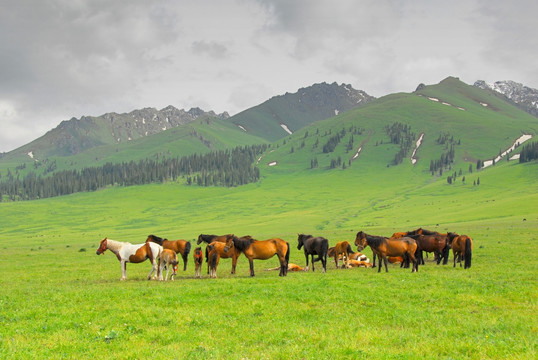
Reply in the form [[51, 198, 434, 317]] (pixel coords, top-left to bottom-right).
[[0, 156, 538, 359]]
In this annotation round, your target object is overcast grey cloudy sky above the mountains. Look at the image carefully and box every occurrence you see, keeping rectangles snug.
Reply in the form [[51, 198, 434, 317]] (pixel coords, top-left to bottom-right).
[[0, 0, 538, 152]]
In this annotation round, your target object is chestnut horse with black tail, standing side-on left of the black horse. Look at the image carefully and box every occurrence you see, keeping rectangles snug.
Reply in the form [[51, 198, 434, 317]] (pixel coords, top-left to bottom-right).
[[224, 236, 290, 276]]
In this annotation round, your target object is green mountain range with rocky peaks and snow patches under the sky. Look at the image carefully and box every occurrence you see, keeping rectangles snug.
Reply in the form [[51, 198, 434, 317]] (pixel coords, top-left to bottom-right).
[[0, 77, 538, 200]]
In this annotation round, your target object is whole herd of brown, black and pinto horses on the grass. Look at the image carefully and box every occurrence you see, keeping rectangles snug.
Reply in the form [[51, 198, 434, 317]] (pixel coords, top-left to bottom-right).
[[96, 228, 473, 280]]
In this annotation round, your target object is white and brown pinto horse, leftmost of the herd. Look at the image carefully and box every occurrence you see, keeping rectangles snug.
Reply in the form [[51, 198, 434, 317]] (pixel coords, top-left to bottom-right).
[[96, 238, 163, 280]]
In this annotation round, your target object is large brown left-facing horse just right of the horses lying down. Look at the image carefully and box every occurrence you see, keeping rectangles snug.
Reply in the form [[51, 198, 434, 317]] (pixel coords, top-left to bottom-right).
[[355, 231, 418, 272]]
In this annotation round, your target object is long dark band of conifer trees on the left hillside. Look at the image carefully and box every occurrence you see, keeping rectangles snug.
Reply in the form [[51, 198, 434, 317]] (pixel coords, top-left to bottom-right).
[[0, 145, 267, 201]]
